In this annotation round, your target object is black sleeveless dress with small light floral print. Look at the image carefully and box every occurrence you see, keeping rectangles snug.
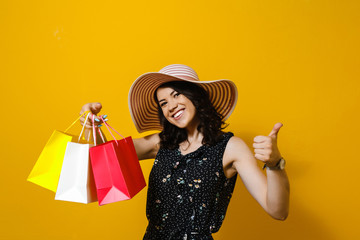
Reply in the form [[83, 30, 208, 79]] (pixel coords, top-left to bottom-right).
[[143, 132, 237, 240]]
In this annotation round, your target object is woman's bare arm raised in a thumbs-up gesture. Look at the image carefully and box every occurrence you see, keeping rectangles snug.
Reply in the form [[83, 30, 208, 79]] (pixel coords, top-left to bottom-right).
[[224, 123, 290, 220]]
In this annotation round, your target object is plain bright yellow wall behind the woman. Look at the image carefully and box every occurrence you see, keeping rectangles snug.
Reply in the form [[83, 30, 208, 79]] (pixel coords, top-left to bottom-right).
[[0, 0, 360, 240]]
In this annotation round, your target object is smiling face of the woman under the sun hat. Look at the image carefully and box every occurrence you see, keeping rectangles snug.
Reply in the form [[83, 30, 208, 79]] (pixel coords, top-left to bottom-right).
[[156, 87, 196, 128]]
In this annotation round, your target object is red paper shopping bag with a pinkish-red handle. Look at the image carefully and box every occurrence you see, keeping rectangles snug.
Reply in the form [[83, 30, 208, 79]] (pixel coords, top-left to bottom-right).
[[90, 115, 146, 206]]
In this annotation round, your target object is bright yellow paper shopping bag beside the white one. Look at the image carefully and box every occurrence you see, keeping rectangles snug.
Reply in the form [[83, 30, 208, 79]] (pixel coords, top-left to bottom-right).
[[27, 112, 88, 192]]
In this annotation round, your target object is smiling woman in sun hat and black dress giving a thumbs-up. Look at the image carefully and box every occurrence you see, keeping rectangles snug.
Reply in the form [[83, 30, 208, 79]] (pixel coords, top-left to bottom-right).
[[81, 64, 289, 239]]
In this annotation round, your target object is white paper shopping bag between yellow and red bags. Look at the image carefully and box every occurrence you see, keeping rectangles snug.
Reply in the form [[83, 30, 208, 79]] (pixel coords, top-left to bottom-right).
[[55, 113, 97, 203]]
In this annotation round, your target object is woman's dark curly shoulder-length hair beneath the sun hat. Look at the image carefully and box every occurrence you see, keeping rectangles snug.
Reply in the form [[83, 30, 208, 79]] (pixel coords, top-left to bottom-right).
[[154, 81, 227, 149]]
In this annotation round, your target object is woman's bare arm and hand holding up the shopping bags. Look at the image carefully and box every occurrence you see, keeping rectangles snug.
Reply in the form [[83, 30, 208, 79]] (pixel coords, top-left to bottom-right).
[[80, 102, 160, 160]]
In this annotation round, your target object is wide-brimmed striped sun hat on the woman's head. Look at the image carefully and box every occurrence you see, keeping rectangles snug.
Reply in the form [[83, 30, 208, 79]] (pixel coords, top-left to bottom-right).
[[129, 64, 237, 133]]
